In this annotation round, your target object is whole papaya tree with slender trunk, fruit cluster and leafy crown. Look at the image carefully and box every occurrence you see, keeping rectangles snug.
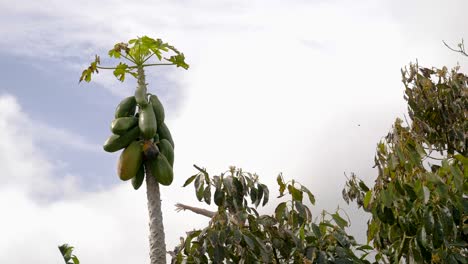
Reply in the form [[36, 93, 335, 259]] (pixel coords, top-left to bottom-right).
[[80, 36, 189, 264]]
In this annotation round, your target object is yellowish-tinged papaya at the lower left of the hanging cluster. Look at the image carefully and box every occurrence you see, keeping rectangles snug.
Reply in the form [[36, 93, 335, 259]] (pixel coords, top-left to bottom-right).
[[117, 141, 143, 181]]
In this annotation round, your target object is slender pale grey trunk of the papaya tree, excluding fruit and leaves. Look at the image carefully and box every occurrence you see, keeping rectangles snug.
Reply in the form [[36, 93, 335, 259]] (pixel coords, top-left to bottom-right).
[[137, 67, 166, 264]]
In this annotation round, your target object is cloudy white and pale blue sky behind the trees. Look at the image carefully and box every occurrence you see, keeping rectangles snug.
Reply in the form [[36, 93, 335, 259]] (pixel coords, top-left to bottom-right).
[[0, 0, 468, 264]]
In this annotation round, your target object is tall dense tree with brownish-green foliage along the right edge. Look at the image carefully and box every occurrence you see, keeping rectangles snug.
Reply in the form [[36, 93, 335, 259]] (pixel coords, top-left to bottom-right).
[[343, 63, 468, 263]]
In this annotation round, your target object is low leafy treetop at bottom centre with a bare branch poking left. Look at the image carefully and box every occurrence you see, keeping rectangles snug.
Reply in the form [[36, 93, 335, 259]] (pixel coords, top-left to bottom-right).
[[170, 166, 371, 263]]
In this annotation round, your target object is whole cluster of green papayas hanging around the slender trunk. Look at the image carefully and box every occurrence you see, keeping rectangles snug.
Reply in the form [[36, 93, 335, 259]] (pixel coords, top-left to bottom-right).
[[104, 92, 174, 190]]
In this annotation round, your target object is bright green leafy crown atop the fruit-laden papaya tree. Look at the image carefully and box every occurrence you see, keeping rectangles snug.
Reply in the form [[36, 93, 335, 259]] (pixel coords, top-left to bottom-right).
[[80, 36, 189, 82]]
